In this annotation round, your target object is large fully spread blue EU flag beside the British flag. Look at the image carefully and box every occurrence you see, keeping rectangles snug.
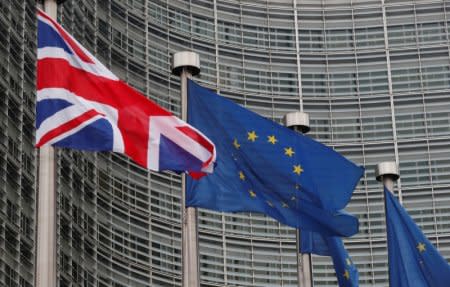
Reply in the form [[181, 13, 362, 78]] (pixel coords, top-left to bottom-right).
[[186, 81, 363, 236]]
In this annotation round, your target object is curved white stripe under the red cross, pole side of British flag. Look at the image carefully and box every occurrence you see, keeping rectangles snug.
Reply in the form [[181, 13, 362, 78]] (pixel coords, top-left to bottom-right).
[[36, 88, 125, 152]]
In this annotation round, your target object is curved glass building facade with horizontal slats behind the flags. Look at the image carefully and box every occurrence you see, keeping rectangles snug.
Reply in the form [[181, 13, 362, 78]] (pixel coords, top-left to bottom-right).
[[0, 0, 450, 287]]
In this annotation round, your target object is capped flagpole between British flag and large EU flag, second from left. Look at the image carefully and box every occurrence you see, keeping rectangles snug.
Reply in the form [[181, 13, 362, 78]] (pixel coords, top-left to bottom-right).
[[172, 51, 200, 287]]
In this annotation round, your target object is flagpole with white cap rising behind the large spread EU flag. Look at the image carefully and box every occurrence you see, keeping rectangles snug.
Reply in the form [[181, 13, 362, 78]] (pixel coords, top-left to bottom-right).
[[284, 112, 313, 287]]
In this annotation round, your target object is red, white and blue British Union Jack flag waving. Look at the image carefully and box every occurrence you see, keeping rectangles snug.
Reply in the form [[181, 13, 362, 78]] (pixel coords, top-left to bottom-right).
[[36, 11, 215, 172]]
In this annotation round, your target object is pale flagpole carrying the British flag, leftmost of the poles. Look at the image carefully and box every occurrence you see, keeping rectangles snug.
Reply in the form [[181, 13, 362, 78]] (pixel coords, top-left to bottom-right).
[[35, 0, 57, 287]]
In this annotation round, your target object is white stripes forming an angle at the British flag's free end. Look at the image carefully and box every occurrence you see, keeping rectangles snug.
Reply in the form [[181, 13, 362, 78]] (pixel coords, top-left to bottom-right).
[[148, 116, 215, 172]]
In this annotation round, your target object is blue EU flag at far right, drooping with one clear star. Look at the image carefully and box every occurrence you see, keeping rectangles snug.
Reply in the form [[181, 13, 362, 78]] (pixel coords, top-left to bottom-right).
[[384, 187, 450, 287]]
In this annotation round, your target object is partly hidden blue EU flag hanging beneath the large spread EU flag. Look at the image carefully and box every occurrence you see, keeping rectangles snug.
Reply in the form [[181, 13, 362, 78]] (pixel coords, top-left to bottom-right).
[[300, 231, 359, 287]]
